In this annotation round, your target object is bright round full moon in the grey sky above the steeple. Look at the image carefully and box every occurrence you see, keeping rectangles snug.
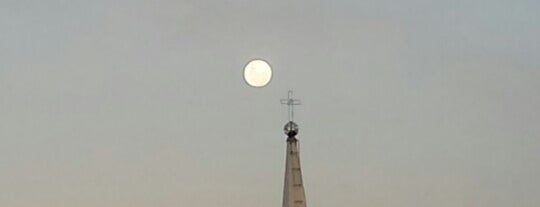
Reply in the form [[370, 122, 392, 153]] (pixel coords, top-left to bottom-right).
[[244, 59, 272, 87]]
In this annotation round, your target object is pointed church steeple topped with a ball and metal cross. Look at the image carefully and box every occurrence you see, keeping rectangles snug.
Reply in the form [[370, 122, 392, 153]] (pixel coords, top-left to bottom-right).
[[281, 91, 306, 207]]
